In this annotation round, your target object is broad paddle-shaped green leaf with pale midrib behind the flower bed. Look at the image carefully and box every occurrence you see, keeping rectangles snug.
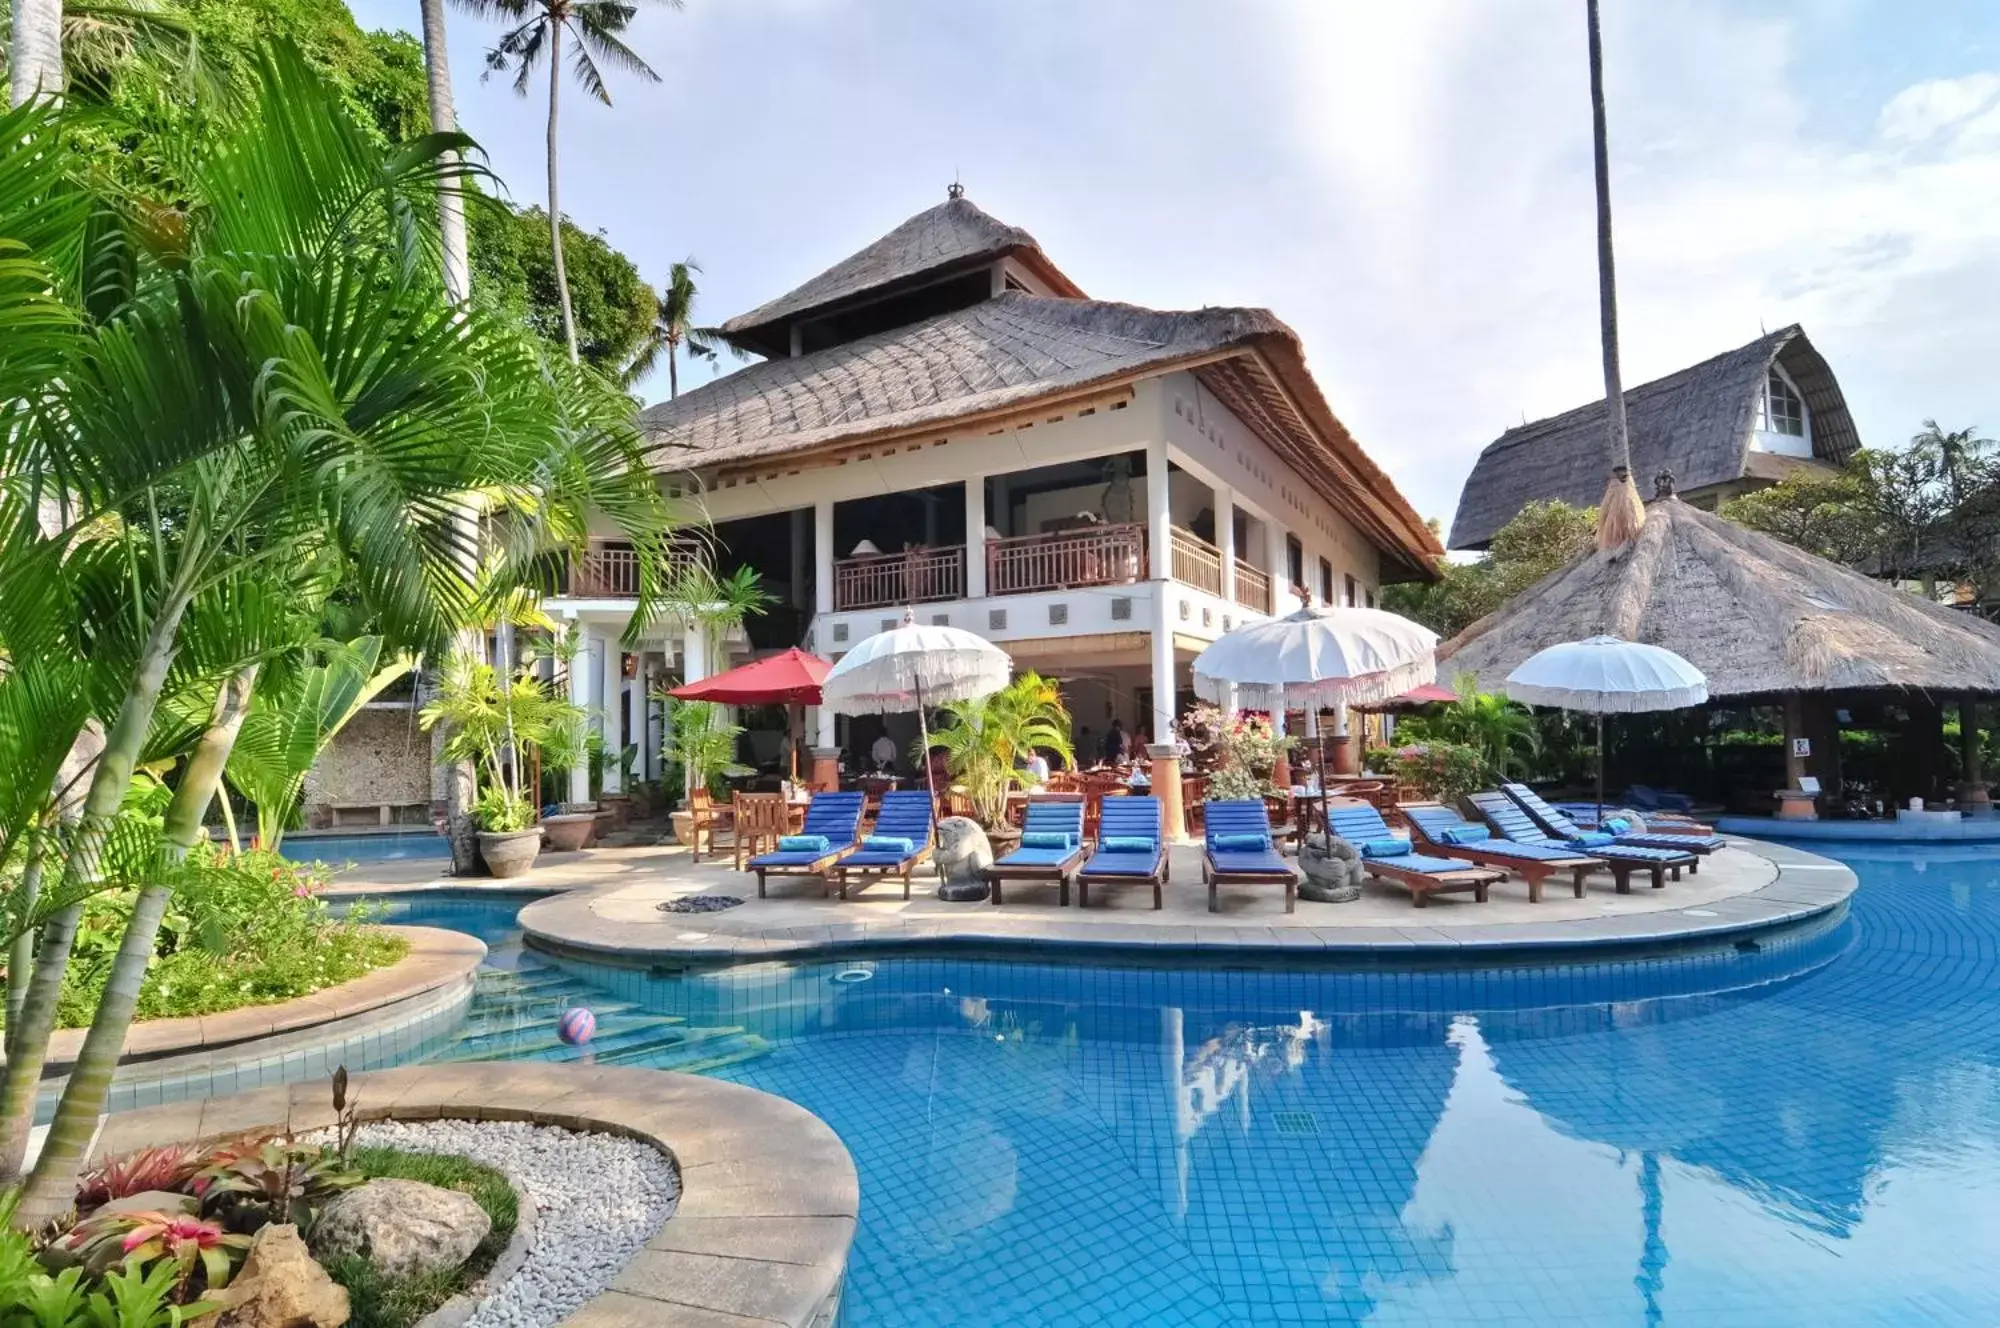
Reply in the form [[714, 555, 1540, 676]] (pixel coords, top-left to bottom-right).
[[224, 636, 416, 848]]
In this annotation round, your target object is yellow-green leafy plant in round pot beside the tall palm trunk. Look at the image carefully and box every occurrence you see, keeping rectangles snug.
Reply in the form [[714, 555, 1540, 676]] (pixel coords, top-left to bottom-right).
[[418, 654, 576, 878]]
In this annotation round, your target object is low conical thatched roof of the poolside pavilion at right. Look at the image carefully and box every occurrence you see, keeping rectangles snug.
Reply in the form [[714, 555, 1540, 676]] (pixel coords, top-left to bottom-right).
[[1438, 498, 2000, 698]]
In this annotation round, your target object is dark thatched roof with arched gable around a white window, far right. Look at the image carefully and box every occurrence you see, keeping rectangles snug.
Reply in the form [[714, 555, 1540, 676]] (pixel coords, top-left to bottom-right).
[[1446, 324, 1860, 548]]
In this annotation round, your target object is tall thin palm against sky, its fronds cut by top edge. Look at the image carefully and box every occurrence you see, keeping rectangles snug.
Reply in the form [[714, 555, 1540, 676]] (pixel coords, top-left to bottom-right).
[[460, 0, 680, 364]]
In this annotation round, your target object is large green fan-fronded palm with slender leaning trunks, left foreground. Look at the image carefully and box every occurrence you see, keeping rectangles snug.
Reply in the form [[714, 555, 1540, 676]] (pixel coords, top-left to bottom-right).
[[0, 50, 684, 1214]]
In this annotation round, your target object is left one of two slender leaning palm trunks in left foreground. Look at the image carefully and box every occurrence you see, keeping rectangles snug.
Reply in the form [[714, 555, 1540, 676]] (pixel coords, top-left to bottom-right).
[[0, 582, 194, 1180]]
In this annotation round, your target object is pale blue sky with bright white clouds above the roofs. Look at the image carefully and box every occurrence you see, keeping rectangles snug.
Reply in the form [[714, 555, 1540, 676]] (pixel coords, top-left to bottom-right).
[[350, 0, 2000, 524]]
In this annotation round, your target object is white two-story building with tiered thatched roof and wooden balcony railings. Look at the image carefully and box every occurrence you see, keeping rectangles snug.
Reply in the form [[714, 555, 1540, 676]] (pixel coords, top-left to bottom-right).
[[548, 186, 1442, 788]]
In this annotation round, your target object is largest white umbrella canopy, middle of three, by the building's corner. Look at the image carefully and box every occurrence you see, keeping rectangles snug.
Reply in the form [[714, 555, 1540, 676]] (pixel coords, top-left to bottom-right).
[[1194, 606, 1438, 780]]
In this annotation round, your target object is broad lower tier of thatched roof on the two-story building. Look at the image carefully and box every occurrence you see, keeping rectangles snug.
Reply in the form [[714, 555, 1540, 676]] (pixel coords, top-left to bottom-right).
[[640, 290, 1442, 576]]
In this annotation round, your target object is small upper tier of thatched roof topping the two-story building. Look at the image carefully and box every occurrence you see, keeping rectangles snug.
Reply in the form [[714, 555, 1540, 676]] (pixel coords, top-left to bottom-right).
[[722, 194, 1082, 348]]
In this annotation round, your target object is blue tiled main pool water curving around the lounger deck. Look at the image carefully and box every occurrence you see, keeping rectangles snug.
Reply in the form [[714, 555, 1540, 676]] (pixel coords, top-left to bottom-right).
[[364, 846, 2000, 1328]]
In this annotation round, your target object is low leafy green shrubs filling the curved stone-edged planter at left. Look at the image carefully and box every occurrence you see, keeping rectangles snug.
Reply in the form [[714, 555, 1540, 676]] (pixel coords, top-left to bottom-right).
[[58, 848, 410, 1028]]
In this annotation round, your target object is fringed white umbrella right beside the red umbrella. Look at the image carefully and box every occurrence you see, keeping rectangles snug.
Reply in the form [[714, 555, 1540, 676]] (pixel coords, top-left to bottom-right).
[[820, 612, 1014, 798]]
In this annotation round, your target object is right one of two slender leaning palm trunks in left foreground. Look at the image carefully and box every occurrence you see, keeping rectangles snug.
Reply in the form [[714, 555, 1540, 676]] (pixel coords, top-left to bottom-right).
[[22, 666, 256, 1220]]
